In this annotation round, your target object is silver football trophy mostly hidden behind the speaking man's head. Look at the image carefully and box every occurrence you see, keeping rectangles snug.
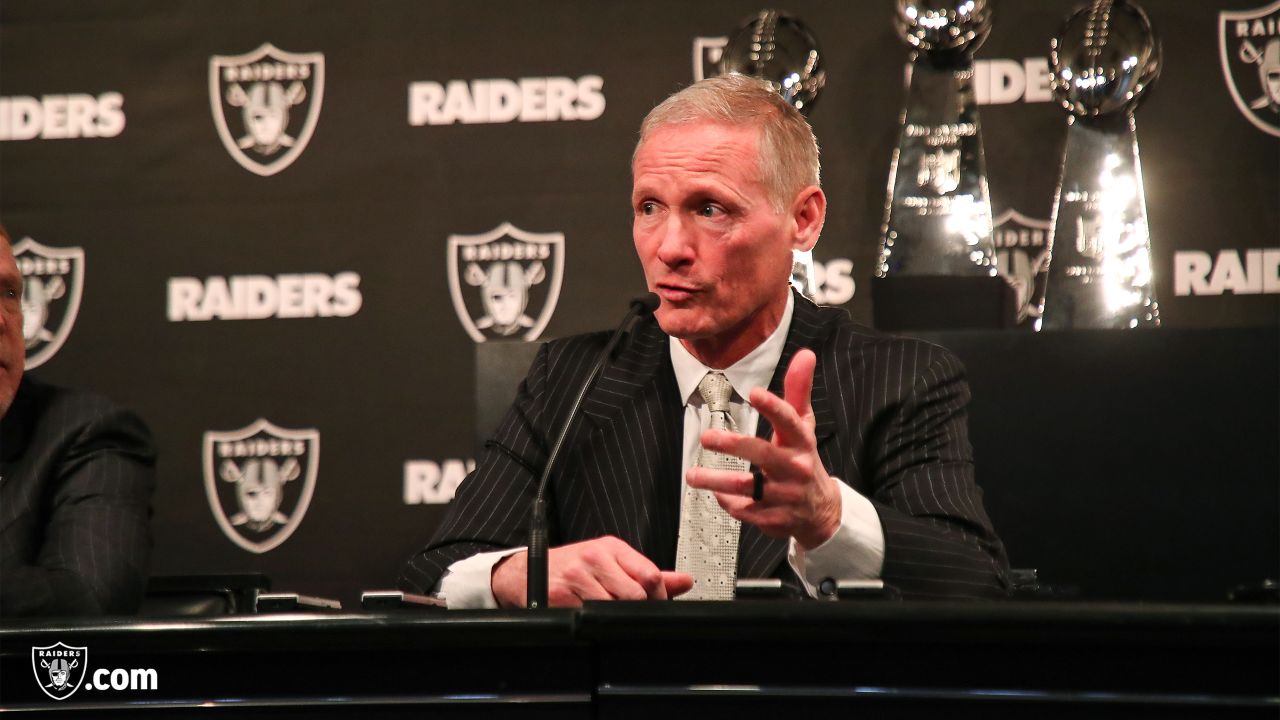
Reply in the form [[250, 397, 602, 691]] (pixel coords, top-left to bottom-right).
[[718, 10, 827, 294]]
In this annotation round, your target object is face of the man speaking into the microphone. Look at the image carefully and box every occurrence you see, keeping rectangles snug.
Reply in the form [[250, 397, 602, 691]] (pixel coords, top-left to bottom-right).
[[631, 122, 795, 342]]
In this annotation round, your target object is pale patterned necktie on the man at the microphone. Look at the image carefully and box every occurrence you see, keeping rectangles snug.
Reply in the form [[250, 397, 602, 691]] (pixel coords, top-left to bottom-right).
[[676, 372, 749, 600]]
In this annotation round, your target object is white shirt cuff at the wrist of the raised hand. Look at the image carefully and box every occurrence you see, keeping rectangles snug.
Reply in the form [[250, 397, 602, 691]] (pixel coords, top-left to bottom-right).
[[787, 478, 884, 600]]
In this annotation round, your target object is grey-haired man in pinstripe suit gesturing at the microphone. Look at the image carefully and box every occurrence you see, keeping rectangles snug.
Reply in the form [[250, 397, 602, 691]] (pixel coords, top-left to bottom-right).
[[401, 76, 1007, 607]]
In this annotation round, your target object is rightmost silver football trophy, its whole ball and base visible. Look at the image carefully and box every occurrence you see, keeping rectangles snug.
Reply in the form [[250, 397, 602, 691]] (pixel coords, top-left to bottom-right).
[[1043, 0, 1160, 329]]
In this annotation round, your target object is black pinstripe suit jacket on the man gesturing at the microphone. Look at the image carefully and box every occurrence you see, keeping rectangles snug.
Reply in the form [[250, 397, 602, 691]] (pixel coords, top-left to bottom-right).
[[401, 296, 1007, 597]]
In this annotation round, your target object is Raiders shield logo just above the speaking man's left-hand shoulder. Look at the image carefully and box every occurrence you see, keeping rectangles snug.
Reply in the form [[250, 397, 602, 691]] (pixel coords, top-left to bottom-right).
[[447, 223, 564, 342]]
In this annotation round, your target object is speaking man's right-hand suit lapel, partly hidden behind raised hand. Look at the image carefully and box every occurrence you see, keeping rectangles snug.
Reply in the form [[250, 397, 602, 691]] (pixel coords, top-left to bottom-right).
[[737, 293, 836, 578]]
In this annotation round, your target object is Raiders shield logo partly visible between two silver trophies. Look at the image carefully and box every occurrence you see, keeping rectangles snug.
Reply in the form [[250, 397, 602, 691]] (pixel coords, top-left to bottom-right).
[[991, 208, 1053, 323]]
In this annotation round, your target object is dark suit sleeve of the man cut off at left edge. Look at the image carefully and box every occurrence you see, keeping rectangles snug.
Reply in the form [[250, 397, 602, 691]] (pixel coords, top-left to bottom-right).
[[0, 396, 155, 616]]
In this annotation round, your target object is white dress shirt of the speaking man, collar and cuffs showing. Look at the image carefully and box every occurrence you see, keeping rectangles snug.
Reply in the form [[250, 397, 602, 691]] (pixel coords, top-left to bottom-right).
[[435, 295, 884, 609]]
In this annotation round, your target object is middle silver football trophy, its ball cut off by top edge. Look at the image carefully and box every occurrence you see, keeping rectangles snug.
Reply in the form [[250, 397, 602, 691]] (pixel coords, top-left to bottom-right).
[[876, 0, 996, 278]]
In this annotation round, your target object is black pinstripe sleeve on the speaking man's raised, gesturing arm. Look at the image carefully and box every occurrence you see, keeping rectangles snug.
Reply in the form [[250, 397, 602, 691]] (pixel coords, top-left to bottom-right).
[[870, 348, 1009, 597]]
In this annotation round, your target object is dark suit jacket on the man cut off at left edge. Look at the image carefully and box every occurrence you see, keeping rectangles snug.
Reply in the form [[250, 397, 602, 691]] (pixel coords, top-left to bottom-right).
[[0, 377, 155, 616]]
